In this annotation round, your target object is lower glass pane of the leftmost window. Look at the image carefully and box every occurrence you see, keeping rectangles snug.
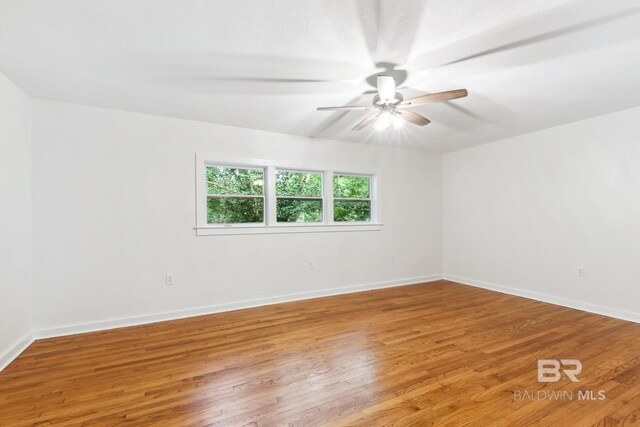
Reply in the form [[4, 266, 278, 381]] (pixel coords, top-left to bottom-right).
[[207, 197, 264, 224]]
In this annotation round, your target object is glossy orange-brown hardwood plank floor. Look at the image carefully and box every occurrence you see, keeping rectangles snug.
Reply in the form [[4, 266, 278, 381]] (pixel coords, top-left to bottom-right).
[[0, 281, 640, 426]]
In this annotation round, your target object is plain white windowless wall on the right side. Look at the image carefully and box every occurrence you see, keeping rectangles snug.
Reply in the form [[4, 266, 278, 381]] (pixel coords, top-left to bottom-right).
[[444, 108, 640, 321]]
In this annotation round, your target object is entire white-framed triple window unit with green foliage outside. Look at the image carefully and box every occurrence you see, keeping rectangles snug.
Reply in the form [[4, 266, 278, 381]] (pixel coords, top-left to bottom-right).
[[195, 159, 382, 236]]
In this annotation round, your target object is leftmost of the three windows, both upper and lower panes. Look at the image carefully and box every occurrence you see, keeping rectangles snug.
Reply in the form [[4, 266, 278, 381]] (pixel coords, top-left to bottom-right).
[[207, 166, 264, 224]]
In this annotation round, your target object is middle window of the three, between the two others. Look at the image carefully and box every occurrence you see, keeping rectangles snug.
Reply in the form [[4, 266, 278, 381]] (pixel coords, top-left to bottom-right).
[[276, 170, 322, 222]]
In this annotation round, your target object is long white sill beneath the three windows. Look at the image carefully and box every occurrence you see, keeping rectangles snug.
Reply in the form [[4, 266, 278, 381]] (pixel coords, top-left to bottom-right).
[[195, 223, 382, 236]]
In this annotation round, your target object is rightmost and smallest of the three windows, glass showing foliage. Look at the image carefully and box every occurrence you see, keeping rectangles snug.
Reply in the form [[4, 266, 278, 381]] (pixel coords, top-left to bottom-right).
[[333, 174, 371, 222]]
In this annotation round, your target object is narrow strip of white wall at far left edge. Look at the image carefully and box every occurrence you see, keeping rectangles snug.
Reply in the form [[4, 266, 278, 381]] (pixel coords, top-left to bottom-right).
[[0, 74, 32, 369]]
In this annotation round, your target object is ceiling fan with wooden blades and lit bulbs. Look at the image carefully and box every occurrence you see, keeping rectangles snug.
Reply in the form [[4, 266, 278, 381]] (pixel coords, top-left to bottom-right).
[[318, 75, 467, 131]]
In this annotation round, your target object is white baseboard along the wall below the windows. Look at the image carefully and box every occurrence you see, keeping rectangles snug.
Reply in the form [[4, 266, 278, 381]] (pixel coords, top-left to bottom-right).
[[35, 274, 442, 339]]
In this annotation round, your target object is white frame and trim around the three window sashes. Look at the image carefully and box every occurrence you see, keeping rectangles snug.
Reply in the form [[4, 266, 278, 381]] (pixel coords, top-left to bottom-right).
[[195, 155, 383, 236]]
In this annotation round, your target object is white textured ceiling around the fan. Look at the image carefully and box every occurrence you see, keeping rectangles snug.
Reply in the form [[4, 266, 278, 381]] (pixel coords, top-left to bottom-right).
[[0, 0, 640, 152]]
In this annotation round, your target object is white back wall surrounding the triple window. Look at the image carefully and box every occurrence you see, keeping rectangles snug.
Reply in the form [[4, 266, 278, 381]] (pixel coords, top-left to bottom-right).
[[33, 100, 442, 328]]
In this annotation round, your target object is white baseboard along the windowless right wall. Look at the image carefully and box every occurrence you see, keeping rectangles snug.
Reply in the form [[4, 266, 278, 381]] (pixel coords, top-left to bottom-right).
[[444, 274, 640, 323]]
